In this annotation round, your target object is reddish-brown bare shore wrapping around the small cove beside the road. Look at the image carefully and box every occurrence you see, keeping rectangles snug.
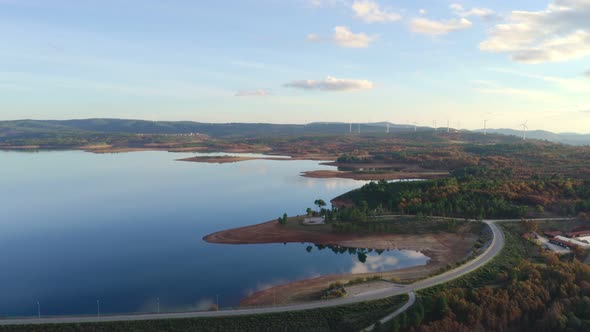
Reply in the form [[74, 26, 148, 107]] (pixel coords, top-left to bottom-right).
[[203, 221, 477, 306]]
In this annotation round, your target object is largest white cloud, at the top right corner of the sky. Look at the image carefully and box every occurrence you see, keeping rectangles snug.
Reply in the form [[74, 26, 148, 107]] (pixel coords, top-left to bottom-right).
[[480, 0, 590, 63]]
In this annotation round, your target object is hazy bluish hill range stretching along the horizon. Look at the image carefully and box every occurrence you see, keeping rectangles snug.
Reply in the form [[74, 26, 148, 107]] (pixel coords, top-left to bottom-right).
[[0, 119, 590, 145]]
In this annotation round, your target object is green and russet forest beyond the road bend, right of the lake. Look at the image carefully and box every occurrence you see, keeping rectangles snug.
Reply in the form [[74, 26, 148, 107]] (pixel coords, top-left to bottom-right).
[[335, 167, 590, 221]]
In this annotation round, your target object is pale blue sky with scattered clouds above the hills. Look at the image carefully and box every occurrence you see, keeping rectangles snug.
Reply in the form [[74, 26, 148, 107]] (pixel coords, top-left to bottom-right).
[[0, 0, 590, 133]]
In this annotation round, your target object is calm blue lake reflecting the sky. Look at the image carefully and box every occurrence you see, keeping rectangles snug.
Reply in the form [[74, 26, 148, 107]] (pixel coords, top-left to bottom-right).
[[0, 151, 427, 316]]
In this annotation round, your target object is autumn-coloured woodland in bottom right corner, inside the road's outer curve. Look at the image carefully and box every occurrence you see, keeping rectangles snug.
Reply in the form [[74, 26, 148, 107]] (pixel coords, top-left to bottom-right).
[[381, 225, 590, 332]]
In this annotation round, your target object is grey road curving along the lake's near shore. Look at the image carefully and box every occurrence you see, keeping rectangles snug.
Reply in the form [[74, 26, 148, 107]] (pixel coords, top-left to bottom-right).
[[0, 219, 508, 325]]
